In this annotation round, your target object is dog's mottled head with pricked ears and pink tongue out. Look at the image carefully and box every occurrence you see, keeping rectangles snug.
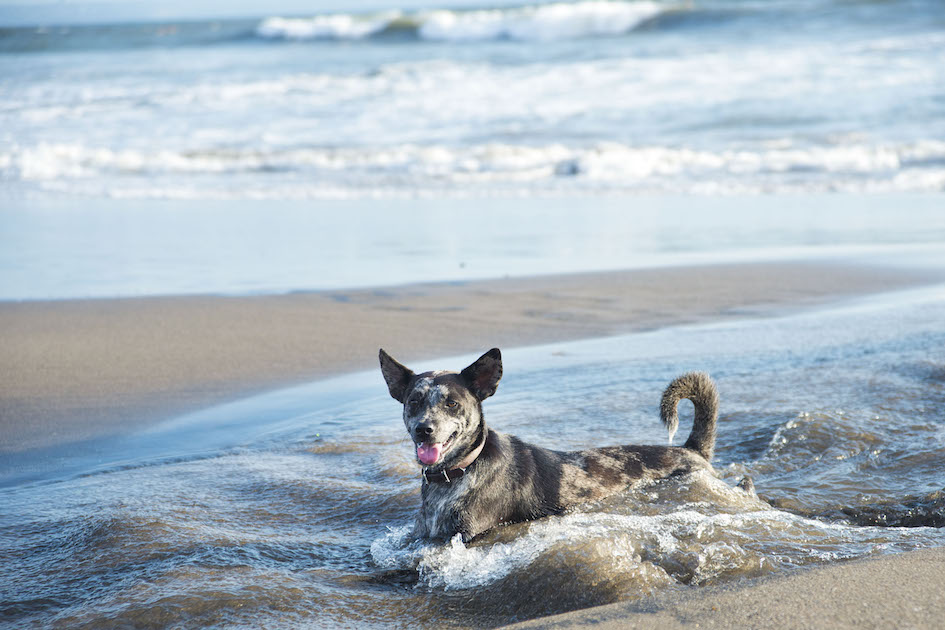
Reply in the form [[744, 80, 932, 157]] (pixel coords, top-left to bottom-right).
[[380, 348, 502, 469]]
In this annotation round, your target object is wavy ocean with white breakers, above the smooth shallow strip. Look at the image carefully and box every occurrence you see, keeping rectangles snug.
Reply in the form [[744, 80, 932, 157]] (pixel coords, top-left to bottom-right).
[[0, 0, 945, 200]]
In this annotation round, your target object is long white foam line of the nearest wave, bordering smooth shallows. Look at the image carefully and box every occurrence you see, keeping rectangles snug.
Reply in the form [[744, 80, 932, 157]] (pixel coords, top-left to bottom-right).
[[7, 140, 945, 198]]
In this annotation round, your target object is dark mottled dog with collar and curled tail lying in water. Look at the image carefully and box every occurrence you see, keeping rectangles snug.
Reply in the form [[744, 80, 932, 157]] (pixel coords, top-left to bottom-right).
[[380, 348, 719, 542]]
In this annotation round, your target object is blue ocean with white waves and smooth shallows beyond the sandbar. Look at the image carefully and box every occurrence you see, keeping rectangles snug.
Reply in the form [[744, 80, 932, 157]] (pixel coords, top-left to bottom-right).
[[0, 0, 945, 300]]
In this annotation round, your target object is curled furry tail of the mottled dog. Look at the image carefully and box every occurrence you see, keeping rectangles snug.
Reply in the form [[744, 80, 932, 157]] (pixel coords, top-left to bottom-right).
[[660, 372, 719, 461]]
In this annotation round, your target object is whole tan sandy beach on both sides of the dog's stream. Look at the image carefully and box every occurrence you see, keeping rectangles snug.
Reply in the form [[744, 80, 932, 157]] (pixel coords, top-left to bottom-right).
[[0, 263, 945, 628]]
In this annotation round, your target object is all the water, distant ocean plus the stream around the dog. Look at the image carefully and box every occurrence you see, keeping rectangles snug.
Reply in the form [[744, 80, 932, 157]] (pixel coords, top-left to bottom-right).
[[0, 0, 945, 628]]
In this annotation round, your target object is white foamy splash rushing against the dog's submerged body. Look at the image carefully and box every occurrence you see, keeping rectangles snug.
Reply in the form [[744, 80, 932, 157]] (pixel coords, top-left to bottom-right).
[[371, 473, 935, 598]]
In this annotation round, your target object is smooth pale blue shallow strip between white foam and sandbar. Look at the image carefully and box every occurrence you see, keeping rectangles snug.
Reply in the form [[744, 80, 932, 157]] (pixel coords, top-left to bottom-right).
[[0, 193, 945, 300]]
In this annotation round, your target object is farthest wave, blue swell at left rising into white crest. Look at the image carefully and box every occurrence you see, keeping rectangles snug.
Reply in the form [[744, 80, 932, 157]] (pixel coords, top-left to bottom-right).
[[0, 0, 680, 54]]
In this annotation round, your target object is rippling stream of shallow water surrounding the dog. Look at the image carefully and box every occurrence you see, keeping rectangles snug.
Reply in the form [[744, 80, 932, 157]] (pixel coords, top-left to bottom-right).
[[0, 286, 945, 628]]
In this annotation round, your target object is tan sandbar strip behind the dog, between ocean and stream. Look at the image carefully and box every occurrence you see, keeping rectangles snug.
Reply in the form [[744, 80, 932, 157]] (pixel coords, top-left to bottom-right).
[[0, 262, 937, 454]]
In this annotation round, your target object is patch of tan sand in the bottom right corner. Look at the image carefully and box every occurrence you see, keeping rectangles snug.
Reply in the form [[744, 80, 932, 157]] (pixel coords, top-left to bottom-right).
[[512, 548, 945, 630]]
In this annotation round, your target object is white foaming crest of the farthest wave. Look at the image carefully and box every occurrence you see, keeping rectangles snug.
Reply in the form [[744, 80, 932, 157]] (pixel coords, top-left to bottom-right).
[[256, 0, 670, 42]]
